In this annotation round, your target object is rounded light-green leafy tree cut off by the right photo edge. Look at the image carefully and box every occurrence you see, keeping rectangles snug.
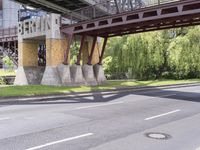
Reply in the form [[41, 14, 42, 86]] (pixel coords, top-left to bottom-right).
[[168, 27, 200, 79]]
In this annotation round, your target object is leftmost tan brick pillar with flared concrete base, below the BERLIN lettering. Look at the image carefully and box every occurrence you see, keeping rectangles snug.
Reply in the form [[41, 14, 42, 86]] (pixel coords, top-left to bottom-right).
[[14, 40, 44, 85]]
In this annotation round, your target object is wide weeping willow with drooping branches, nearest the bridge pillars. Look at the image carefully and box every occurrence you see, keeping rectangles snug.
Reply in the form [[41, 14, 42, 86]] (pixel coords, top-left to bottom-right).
[[105, 32, 169, 79]]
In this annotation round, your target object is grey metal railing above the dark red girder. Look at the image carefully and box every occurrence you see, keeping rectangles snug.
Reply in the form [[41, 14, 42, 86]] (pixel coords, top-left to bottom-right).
[[67, 0, 180, 24]]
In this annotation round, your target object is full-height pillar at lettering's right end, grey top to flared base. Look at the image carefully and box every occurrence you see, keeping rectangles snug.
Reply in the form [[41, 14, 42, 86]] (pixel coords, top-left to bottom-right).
[[41, 14, 71, 86]]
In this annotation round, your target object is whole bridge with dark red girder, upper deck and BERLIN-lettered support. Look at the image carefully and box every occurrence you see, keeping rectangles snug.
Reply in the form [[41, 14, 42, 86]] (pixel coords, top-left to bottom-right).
[[9, 0, 200, 85]]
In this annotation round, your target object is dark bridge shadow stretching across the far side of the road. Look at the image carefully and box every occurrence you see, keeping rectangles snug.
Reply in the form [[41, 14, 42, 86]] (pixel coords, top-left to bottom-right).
[[0, 85, 200, 105]]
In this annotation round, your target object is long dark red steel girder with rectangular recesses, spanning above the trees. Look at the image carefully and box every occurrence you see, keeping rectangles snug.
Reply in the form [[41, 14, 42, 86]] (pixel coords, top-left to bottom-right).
[[61, 0, 200, 37]]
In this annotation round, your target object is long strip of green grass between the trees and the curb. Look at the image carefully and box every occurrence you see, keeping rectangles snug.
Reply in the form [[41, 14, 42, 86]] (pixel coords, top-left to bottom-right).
[[0, 79, 200, 97]]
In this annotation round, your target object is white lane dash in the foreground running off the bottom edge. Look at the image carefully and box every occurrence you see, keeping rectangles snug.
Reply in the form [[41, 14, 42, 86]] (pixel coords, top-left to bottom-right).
[[25, 133, 93, 150]]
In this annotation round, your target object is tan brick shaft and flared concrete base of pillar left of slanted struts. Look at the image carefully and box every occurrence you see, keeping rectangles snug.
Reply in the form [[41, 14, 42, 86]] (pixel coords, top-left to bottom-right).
[[42, 38, 71, 86]]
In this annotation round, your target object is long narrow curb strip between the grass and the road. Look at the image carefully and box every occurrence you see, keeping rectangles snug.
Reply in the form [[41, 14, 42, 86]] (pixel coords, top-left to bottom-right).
[[0, 82, 200, 103]]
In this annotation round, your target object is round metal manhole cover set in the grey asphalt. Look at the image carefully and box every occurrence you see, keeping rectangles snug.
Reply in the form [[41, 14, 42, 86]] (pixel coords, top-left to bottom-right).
[[145, 132, 171, 140]]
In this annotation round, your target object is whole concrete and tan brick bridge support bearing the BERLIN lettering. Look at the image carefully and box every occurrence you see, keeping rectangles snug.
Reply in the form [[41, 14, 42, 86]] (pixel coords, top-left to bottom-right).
[[15, 14, 106, 86]]
